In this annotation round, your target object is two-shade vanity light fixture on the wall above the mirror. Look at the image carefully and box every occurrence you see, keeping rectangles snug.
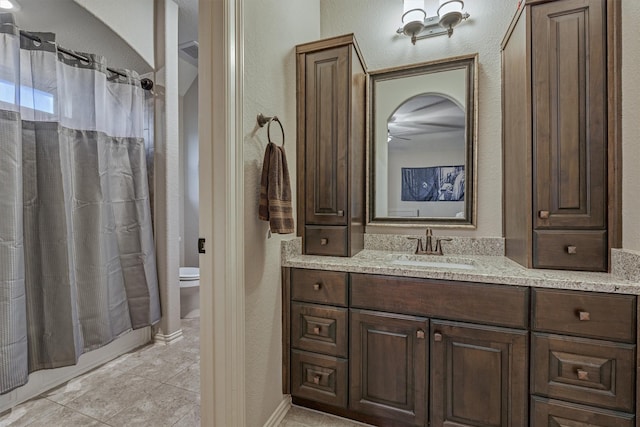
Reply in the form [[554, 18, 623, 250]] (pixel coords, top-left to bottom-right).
[[397, 0, 471, 44]]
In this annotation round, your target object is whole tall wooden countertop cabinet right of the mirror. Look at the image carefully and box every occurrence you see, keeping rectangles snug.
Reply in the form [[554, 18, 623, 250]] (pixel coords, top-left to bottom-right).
[[502, 0, 620, 271]]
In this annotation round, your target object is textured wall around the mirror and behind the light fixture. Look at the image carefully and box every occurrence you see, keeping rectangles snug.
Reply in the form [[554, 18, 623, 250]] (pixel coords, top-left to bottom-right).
[[320, 0, 517, 236]]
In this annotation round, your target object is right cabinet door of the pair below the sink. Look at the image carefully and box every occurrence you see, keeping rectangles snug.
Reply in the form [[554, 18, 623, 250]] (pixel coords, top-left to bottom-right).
[[431, 320, 528, 427]]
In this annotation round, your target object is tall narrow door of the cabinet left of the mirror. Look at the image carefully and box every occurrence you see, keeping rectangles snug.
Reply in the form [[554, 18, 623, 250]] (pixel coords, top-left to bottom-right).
[[304, 46, 350, 225]]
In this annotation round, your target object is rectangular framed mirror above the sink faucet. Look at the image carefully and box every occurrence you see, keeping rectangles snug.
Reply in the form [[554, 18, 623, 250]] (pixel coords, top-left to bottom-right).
[[368, 55, 477, 228]]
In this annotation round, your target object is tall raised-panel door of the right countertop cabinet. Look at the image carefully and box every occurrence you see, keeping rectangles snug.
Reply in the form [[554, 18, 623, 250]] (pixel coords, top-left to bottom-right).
[[531, 0, 607, 229]]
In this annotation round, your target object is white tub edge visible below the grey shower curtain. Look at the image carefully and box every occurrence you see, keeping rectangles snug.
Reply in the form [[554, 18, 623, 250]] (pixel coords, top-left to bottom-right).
[[0, 327, 151, 413]]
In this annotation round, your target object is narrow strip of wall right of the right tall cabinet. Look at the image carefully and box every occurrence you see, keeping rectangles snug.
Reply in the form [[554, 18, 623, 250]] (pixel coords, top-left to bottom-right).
[[622, 0, 640, 251]]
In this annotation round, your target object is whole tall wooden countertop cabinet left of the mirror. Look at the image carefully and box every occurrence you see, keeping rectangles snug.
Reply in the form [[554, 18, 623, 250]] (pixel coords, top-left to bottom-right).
[[296, 35, 366, 256]]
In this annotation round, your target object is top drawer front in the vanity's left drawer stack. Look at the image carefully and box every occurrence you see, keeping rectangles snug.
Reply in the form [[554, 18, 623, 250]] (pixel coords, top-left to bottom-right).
[[291, 269, 348, 307]]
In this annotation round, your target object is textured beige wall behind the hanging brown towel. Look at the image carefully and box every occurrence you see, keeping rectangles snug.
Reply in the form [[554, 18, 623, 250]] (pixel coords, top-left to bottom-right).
[[243, 0, 320, 426]]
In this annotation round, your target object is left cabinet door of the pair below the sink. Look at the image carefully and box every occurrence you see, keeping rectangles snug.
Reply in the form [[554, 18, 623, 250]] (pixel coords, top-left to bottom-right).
[[349, 310, 429, 426]]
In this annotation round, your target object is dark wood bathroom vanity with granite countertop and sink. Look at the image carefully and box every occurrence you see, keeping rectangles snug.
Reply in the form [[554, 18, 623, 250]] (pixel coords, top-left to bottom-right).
[[283, 244, 640, 427]]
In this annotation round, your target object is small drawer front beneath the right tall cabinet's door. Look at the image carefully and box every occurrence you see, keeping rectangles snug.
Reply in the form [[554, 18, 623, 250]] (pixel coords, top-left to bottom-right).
[[533, 230, 608, 271]]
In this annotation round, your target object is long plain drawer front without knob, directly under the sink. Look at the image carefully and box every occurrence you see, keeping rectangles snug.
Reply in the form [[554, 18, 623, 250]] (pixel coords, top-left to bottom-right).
[[351, 274, 529, 329]]
